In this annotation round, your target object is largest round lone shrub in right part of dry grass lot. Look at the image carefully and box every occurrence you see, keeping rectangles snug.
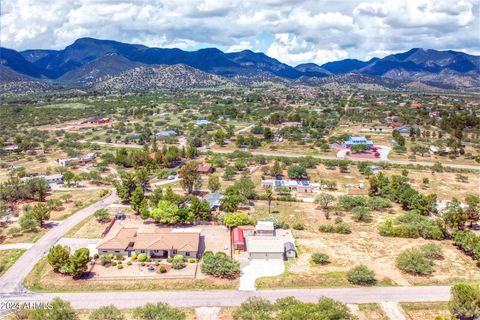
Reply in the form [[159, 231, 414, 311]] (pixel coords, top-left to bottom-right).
[[395, 248, 433, 275]]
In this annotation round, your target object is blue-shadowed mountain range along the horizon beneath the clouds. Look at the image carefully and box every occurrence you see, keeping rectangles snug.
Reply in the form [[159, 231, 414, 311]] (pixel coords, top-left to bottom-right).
[[0, 38, 480, 91]]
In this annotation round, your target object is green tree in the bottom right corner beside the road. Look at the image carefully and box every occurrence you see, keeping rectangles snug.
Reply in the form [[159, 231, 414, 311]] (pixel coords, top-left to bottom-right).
[[448, 283, 480, 320]]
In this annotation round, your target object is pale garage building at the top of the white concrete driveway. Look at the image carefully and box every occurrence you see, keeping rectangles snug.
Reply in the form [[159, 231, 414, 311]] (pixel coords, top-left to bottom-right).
[[247, 237, 285, 260]]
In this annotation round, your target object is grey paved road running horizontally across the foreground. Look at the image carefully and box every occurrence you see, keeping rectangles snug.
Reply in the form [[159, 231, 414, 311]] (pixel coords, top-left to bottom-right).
[[0, 286, 450, 309]]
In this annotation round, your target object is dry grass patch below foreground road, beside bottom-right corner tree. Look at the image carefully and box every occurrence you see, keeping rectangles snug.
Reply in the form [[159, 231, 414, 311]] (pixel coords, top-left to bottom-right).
[[400, 302, 451, 320]]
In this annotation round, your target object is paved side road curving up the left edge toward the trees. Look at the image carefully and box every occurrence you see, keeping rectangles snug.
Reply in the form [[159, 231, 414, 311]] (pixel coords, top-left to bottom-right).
[[0, 192, 118, 293]]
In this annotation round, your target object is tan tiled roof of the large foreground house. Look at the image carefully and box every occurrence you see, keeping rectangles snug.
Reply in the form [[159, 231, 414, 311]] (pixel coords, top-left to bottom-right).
[[97, 222, 200, 252]]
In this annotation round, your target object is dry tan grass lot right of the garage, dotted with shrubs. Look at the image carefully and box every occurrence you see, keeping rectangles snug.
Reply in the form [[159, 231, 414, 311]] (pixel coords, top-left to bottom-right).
[[252, 201, 480, 288]]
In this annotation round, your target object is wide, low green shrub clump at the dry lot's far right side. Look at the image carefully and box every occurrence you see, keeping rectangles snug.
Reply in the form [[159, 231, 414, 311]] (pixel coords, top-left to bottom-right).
[[378, 212, 445, 240]]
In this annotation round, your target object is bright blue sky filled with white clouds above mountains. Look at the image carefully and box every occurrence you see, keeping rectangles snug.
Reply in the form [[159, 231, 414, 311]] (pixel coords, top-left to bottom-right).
[[0, 0, 480, 65]]
